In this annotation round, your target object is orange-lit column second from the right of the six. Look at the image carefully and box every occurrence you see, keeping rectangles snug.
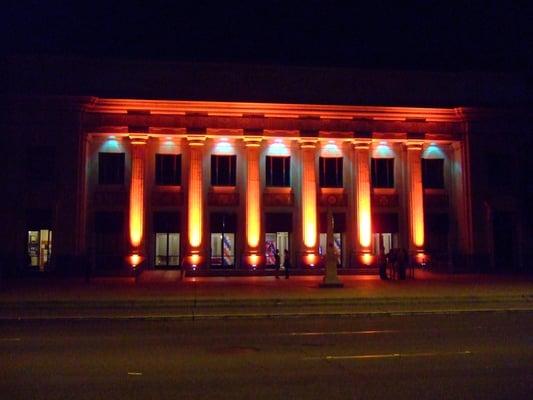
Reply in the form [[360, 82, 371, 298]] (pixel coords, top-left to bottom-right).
[[354, 140, 372, 254]]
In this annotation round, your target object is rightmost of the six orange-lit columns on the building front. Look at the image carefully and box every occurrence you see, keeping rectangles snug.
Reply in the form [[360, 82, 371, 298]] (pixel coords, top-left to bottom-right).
[[407, 141, 424, 252]]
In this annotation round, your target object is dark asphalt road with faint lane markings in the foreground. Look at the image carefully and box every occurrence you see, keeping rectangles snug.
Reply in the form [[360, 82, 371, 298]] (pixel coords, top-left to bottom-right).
[[0, 312, 533, 400]]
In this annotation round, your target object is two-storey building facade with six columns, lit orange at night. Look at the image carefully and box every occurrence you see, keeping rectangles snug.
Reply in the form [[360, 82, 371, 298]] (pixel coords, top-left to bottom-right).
[[4, 57, 529, 272]]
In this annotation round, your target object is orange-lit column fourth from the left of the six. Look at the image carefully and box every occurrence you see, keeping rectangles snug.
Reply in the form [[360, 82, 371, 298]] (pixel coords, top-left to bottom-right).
[[301, 141, 317, 253]]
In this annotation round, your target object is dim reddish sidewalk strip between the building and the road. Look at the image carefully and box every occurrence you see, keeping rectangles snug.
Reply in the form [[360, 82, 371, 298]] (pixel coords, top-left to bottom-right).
[[0, 271, 533, 319]]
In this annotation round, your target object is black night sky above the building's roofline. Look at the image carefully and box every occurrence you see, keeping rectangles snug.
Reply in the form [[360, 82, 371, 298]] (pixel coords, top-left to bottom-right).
[[0, 0, 533, 71]]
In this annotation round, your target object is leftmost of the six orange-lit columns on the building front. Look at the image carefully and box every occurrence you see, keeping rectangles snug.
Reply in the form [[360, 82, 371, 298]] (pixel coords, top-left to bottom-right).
[[129, 135, 147, 254]]
